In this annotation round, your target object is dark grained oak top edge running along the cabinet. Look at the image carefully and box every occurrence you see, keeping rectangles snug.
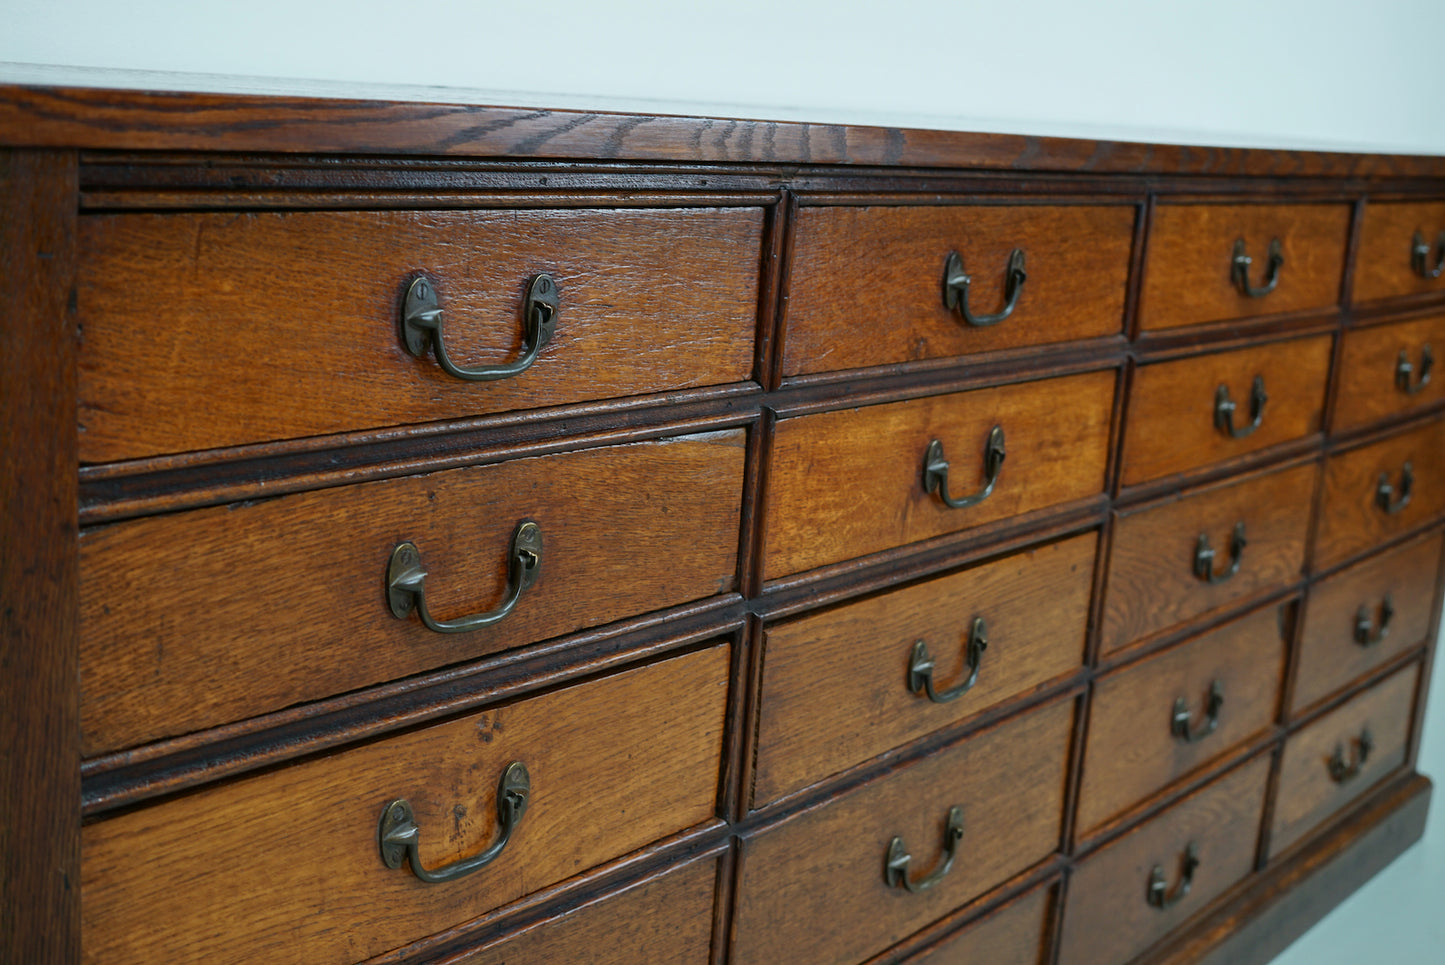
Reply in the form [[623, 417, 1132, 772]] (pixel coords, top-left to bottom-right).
[[0, 85, 1445, 178]]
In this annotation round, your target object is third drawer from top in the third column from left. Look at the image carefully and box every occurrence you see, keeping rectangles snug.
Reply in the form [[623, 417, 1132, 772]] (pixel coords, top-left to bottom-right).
[[1101, 465, 1316, 653]]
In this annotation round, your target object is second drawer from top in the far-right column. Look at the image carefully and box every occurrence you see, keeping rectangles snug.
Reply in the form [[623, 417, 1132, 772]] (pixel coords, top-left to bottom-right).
[[1334, 316, 1445, 432]]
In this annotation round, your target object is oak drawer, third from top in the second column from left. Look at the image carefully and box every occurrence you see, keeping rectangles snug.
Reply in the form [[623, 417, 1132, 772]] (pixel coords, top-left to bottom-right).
[[753, 533, 1098, 808]]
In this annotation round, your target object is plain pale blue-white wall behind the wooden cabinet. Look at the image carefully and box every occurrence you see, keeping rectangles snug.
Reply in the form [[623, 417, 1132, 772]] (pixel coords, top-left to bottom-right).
[[0, 0, 1445, 965]]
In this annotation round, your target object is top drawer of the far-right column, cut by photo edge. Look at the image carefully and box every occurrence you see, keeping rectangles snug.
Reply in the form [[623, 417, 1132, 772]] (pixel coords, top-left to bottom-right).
[[1353, 201, 1445, 302]]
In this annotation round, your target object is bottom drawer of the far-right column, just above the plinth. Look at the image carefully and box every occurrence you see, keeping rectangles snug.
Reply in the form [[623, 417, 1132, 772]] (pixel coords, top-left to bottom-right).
[[1269, 663, 1420, 858]]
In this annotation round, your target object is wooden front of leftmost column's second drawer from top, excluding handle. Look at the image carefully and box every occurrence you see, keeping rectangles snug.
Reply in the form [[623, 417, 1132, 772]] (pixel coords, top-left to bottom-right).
[[81, 429, 744, 754]]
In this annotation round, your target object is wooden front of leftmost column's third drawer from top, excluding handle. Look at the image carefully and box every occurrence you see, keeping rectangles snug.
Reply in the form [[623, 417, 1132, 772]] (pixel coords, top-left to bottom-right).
[[81, 646, 728, 965]]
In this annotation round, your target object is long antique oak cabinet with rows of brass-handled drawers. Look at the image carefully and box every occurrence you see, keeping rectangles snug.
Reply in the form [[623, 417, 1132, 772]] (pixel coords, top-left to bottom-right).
[[0, 87, 1445, 965]]
